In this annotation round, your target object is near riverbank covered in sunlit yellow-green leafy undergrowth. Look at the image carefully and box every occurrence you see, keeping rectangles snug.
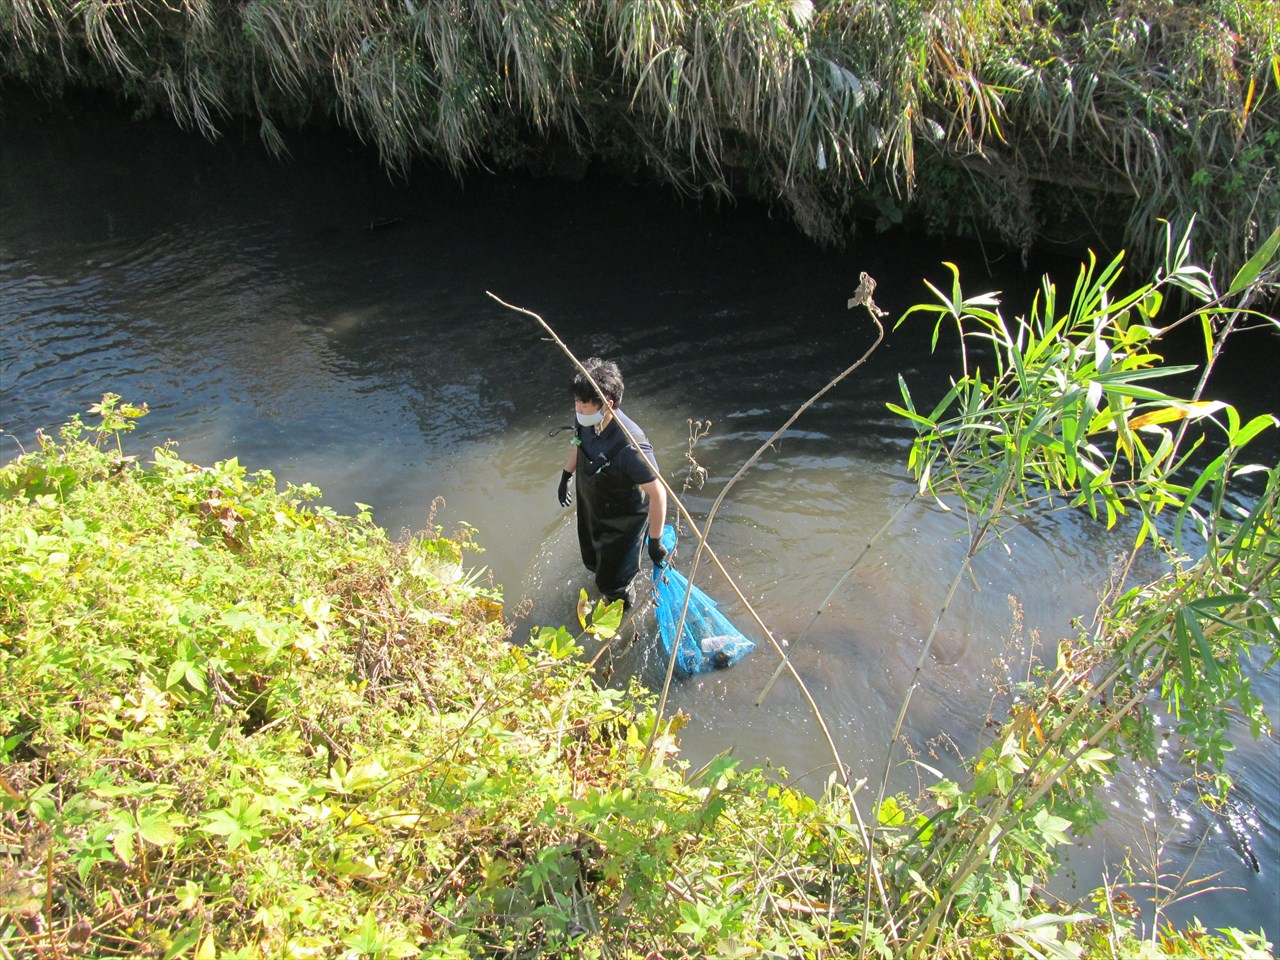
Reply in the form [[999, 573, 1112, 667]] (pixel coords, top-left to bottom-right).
[[0, 394, 1267, 959]]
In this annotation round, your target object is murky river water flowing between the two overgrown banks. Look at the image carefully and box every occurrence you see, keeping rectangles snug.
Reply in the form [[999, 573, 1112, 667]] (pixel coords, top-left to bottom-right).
[[0, 99, 1280, 934]]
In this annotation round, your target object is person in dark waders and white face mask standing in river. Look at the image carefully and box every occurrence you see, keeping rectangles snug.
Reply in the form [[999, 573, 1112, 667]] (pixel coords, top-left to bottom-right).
[[557, 357, 667, 609]]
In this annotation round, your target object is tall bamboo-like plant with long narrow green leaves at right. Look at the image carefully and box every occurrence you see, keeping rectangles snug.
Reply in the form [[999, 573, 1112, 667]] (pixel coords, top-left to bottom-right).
[[879, 230, 1280, 956]]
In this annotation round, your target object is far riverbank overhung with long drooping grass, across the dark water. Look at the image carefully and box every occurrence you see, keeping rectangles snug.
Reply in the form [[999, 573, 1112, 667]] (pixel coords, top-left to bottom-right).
[[0, 0, 1280, 275]]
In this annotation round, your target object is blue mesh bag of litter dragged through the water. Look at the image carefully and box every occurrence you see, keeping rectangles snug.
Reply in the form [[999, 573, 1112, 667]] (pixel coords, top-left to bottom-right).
[[653, 524, 755, 676]]
